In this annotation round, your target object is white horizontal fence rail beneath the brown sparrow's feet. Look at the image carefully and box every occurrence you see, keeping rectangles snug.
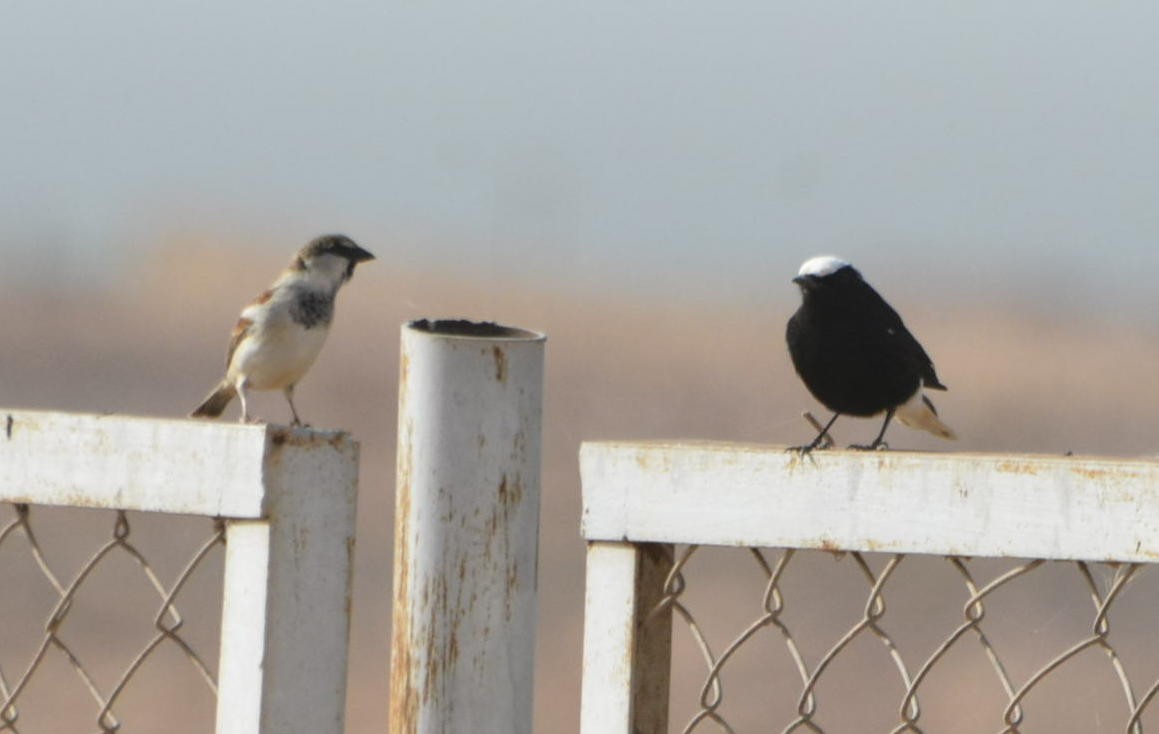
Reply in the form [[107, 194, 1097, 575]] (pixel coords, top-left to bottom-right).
[[0, 408, 273, 517]]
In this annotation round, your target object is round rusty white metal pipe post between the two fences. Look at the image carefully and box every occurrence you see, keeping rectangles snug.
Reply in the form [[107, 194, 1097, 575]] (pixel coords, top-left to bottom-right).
[[391, 320, 545, 734]]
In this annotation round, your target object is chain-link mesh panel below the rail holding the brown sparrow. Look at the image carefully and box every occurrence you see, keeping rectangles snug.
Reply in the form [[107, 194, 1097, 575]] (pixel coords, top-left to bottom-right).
[[0, 504, 225, 734]]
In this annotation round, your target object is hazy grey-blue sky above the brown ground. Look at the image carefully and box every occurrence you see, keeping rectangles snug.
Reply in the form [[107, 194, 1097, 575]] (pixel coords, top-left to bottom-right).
[[0, 0, 1159, 311]]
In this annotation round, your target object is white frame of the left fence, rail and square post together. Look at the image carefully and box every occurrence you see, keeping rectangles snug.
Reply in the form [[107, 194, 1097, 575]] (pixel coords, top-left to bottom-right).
[[0, 409, 358, 734]]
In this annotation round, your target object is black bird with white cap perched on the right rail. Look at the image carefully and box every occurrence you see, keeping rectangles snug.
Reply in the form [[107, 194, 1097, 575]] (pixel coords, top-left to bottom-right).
[[785, 255, 957, 452]]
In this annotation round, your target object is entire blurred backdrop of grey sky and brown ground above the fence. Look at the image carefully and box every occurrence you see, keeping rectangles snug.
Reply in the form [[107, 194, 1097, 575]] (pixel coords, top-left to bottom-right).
[[0, 0, 1159, 733]]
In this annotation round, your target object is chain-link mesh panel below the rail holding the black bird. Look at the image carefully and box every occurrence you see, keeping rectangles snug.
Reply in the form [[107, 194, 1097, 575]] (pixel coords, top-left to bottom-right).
[[646, 546, 1159, 734]]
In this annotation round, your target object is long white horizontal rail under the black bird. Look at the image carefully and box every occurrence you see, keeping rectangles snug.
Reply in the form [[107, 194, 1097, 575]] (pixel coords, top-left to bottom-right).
[[581, 443, 1159, 561]]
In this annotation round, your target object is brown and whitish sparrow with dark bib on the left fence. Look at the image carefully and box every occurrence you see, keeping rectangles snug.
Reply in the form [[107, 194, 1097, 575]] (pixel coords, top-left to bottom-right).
[[189, 234, 374, 426]]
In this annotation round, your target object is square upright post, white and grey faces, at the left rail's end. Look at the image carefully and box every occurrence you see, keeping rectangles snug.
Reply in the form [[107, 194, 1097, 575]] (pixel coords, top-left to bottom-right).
[[218, 431, 358, 734]]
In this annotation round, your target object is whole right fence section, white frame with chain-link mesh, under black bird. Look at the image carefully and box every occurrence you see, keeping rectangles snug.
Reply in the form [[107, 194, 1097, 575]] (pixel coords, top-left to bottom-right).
[[581, 443, 1159, 734]]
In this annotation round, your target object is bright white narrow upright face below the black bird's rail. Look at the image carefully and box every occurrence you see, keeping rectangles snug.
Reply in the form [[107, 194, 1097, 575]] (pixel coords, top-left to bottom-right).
[[580, 542, 639, 734]]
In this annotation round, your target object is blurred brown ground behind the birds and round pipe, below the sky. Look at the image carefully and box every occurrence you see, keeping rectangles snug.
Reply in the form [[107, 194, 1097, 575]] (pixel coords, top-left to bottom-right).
[[0, 238, 1159, 734]]
